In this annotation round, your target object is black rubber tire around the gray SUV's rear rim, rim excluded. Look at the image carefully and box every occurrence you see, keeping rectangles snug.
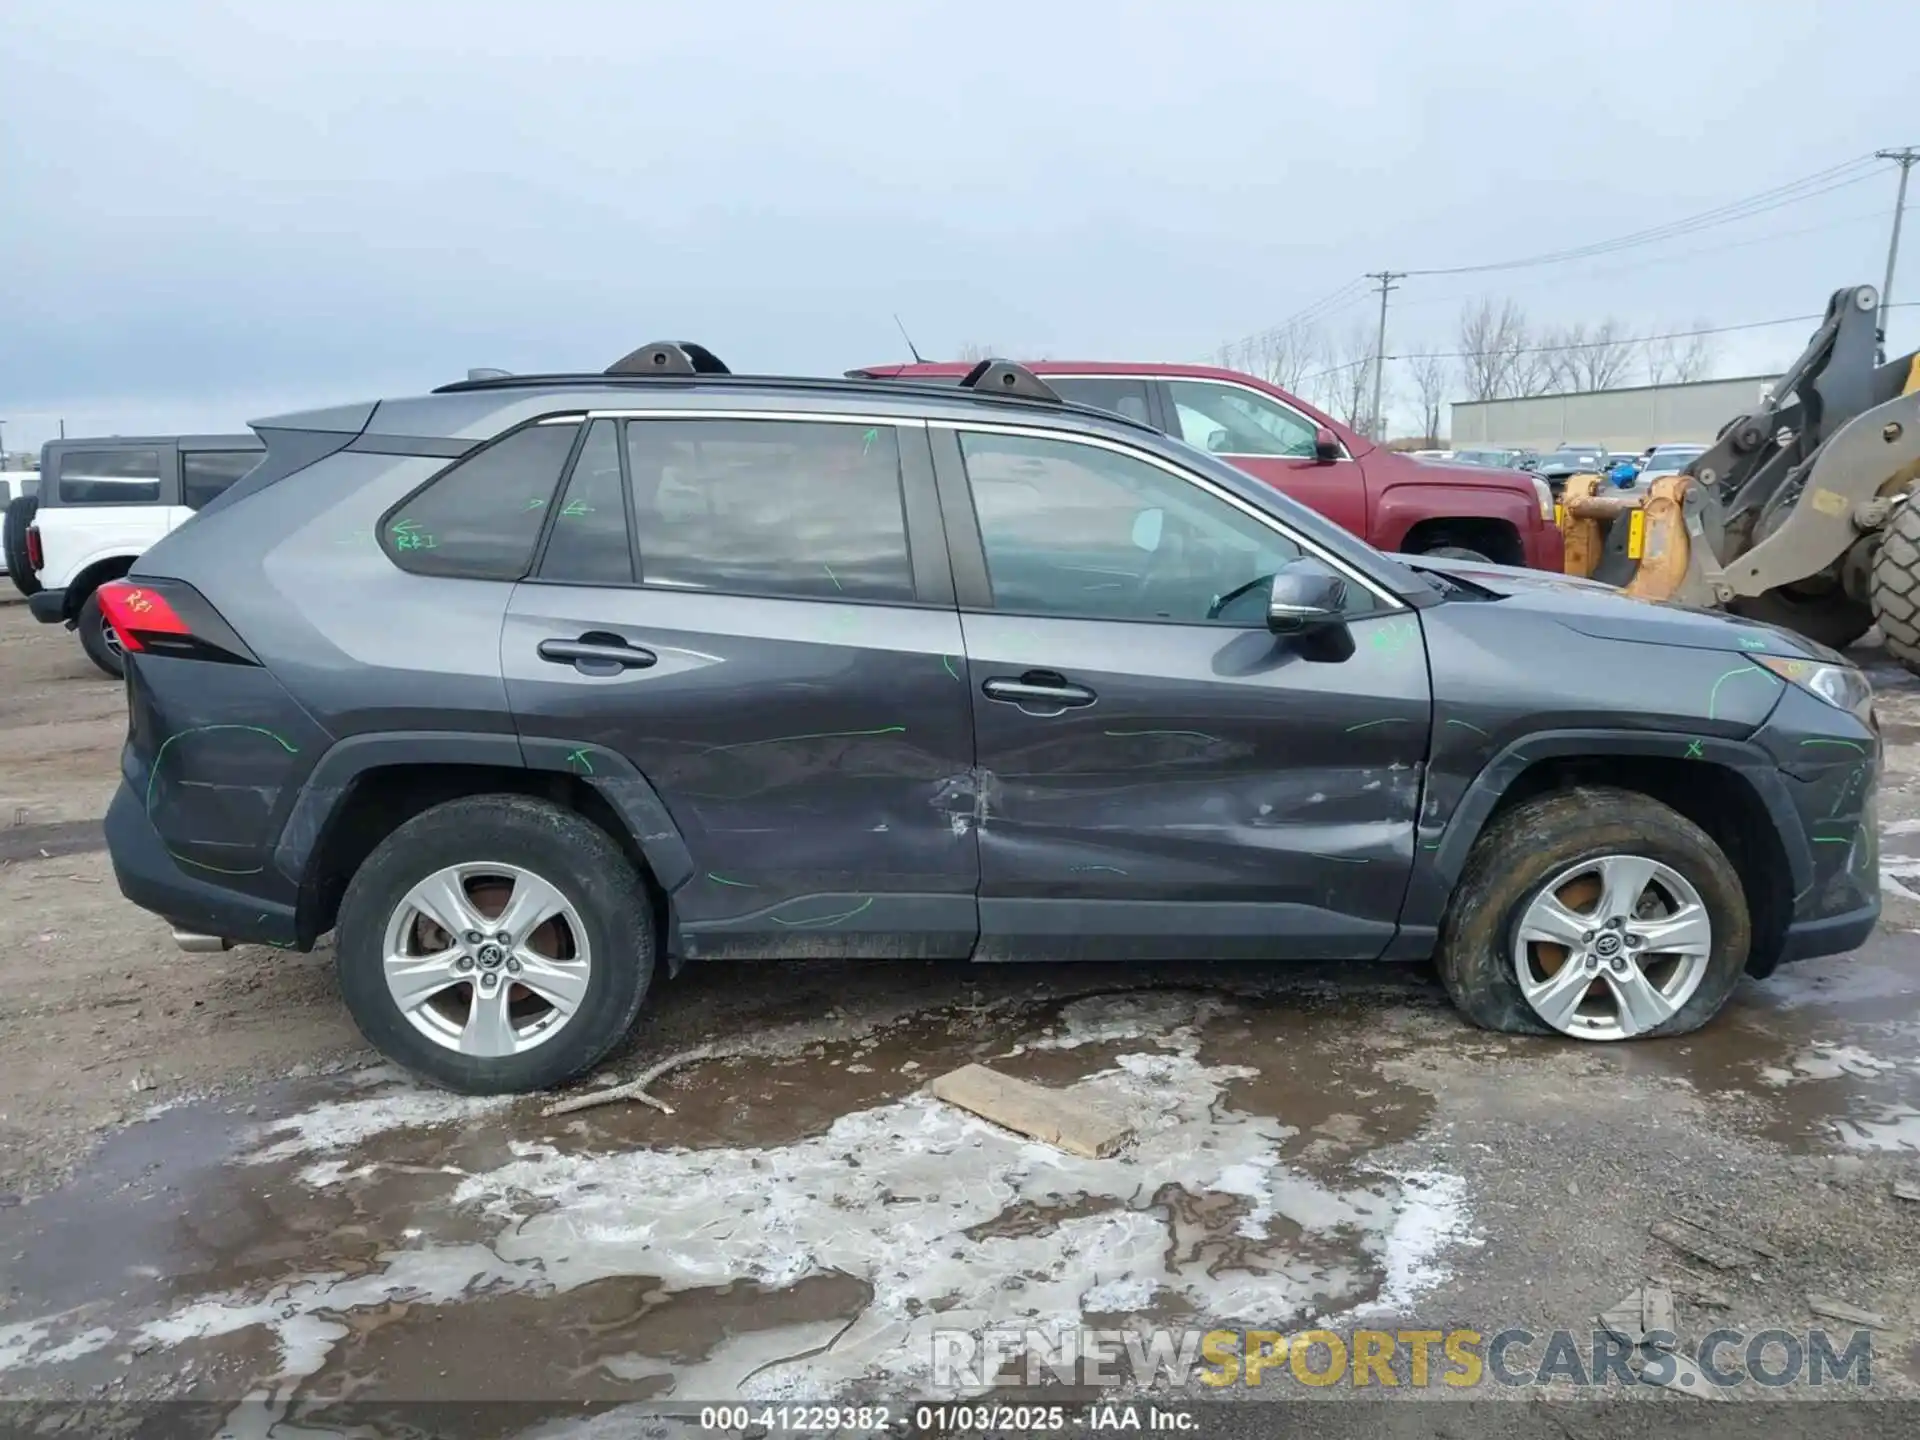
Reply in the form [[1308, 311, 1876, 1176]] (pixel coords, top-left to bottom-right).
[[336, 795, 653, 1094]]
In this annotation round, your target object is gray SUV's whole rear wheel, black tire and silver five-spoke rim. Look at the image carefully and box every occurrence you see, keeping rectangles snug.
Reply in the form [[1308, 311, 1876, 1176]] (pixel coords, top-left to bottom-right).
[[336, 795, 655, 1094]]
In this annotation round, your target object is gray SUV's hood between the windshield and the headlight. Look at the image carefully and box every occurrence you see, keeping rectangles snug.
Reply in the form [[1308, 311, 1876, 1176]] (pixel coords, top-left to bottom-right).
[[1405, 555, 1853, 666]]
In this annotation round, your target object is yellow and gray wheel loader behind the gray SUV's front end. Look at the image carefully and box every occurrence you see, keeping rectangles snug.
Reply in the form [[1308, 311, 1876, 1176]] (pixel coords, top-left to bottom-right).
[[1559, 284, 1920, 674]]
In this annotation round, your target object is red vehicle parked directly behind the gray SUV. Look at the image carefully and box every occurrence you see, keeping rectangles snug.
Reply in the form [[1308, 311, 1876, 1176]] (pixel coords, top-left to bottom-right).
[[852, 361, 1563, 570]]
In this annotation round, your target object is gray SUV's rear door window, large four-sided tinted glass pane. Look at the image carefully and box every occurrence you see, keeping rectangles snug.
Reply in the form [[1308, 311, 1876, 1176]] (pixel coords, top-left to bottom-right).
[[626, 420, 914, 603]]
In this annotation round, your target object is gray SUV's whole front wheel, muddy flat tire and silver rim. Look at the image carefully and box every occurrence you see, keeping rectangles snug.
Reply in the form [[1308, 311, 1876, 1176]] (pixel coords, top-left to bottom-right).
[[1434, 785, 1751, 1041]]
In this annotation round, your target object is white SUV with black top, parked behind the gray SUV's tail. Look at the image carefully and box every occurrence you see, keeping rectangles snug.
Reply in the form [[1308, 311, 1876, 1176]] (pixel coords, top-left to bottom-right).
[[4, 434, 267, 678]]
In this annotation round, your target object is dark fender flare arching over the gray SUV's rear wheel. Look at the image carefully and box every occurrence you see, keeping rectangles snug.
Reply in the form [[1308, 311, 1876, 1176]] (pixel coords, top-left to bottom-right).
[[273, 730, 693, 895]]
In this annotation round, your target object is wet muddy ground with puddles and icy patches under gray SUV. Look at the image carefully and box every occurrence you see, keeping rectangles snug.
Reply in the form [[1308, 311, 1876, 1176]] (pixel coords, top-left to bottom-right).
[[0, 597, 1920, 1434]]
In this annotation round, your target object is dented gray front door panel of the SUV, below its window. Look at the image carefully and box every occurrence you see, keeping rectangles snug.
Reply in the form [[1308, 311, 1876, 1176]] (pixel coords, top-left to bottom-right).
[[962, 612, 1432, 958]]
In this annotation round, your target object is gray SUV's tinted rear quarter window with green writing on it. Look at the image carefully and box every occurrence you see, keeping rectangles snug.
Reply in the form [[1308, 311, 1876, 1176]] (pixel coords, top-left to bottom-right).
[[380, 422, 580, 580]]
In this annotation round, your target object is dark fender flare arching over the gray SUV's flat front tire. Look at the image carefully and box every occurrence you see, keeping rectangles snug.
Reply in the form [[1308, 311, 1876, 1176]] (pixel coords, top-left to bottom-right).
[[1386, 730, 1814, 958]]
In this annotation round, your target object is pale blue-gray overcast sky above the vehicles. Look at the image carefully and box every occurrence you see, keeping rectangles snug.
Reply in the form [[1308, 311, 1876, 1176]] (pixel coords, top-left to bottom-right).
[[0, 0, 1920, 449]]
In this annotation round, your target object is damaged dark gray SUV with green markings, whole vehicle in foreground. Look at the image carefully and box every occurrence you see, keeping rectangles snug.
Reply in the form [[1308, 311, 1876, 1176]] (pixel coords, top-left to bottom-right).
[[102, 344, 1880, 1092]]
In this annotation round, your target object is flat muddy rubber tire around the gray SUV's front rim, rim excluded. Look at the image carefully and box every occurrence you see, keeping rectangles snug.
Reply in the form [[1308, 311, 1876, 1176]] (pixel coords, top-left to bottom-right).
[[1434, 785, 1751, 1039]]
